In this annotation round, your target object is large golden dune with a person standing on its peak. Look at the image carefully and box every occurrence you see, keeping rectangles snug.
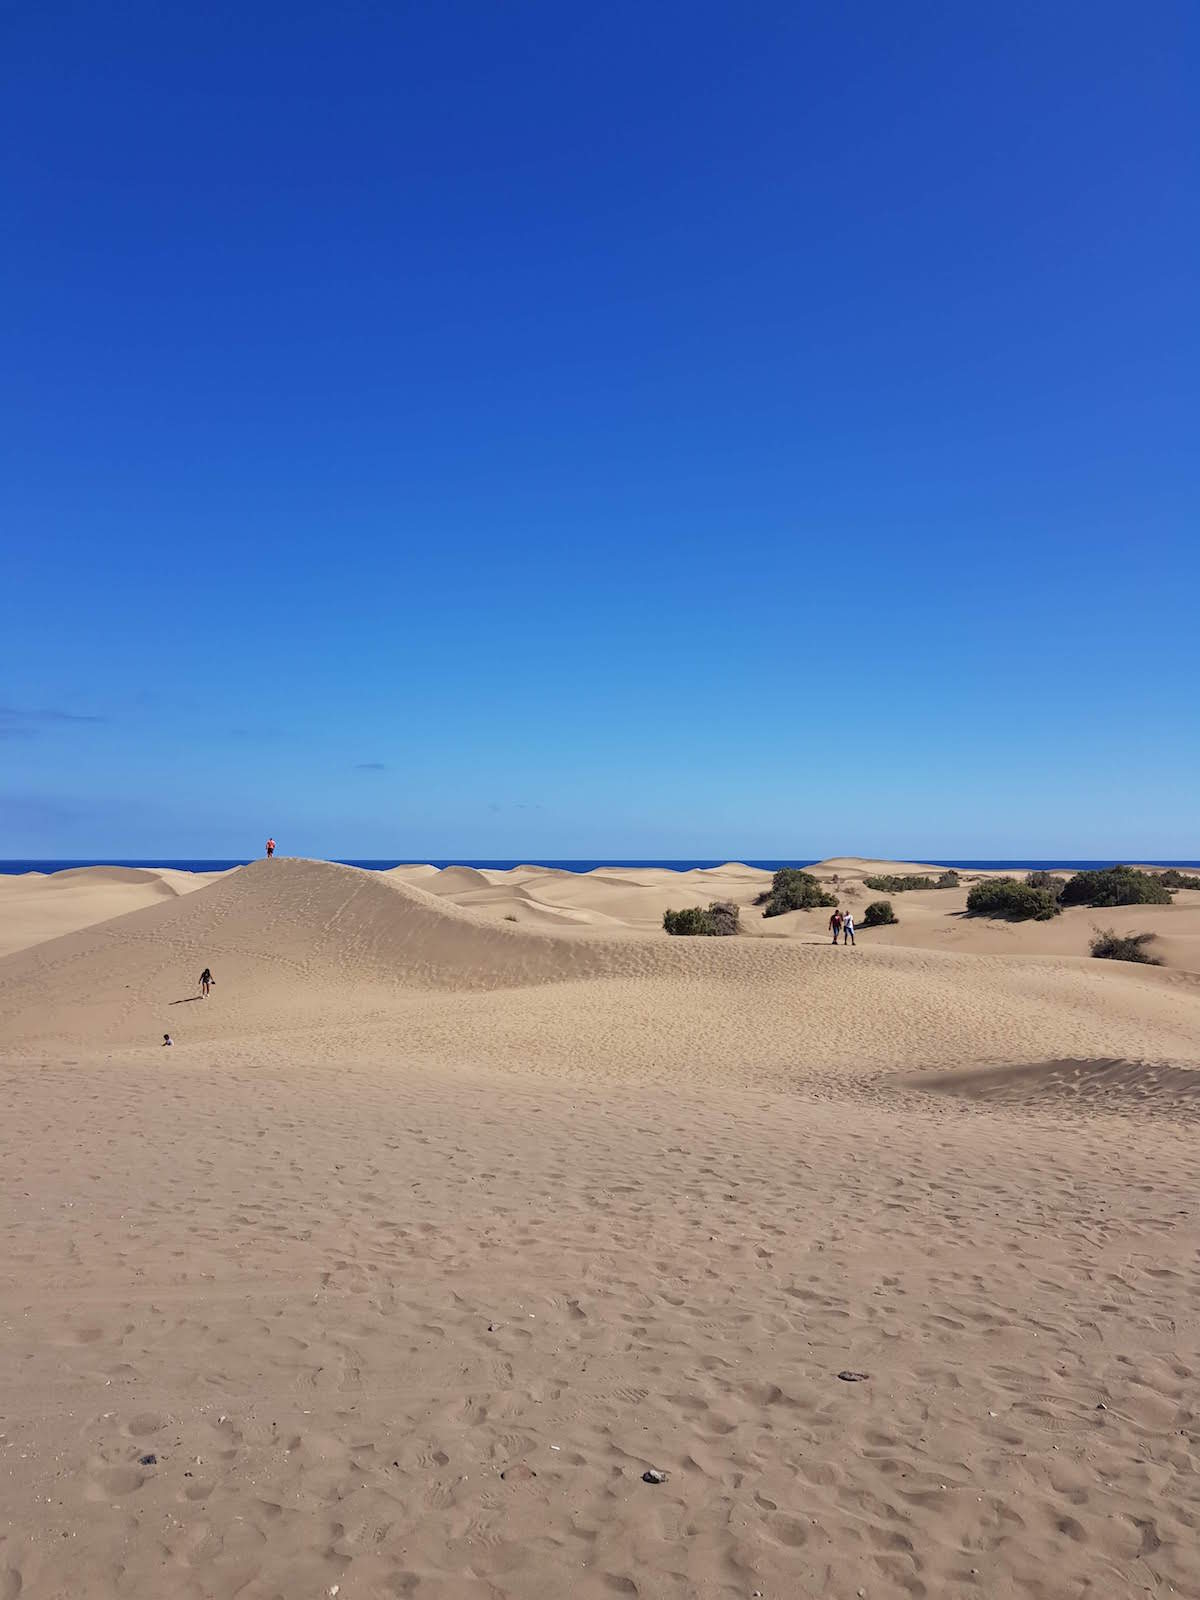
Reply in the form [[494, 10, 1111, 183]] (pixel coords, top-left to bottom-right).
[[0, 859, 1200, 1082]]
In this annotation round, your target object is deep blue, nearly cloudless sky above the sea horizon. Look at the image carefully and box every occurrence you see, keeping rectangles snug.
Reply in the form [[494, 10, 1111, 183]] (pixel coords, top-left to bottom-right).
[[0, 0, 1200, 858]]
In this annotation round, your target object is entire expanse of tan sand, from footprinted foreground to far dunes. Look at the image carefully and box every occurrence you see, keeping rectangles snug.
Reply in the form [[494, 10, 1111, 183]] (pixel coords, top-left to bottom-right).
[[0, 858, 1200, 1600]]
